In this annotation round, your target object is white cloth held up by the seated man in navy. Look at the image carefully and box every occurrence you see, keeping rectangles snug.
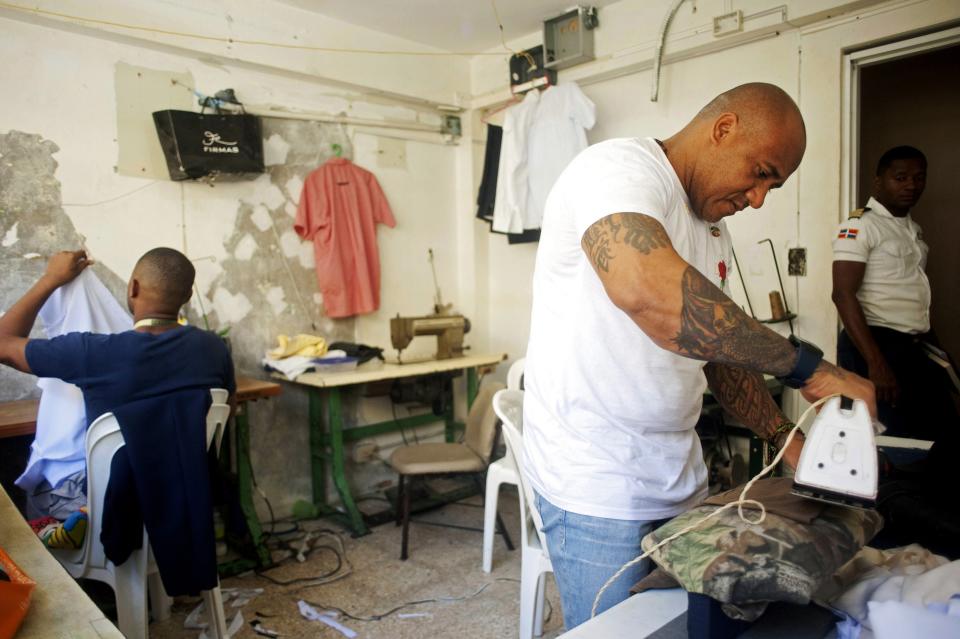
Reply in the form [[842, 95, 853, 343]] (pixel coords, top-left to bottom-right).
[[15, 269, 133, 492]]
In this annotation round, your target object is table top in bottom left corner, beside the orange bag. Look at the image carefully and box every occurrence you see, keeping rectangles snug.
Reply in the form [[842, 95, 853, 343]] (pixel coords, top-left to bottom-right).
[[0, 486, 123, 639]]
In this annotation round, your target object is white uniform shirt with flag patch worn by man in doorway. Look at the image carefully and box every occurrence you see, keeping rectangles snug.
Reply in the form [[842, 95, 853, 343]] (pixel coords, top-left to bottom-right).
[[833, 198, 930, 334]]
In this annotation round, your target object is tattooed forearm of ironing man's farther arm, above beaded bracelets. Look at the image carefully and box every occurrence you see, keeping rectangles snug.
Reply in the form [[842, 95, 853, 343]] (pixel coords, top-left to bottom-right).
[[703, 363, 787, 441]]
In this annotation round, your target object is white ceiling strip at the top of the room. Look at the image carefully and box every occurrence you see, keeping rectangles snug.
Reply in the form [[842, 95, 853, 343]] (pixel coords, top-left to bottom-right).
[[280, 0, 615, 51]]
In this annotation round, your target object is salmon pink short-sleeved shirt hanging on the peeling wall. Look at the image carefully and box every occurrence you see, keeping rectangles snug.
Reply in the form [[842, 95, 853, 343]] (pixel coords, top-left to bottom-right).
[[293, 158, 397, 317]]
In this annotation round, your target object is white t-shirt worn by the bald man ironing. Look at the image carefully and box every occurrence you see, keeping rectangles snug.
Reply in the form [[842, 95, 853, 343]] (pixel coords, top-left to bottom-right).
[[523, 138, 731, 520]]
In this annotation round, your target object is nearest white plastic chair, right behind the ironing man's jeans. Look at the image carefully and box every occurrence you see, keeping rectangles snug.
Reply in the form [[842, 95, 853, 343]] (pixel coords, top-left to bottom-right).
[[493, 389, 553, 639]]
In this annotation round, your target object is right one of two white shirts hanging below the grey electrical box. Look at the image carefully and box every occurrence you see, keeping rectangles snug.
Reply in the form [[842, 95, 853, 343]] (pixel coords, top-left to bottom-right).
[[523, 82, 596, 229]]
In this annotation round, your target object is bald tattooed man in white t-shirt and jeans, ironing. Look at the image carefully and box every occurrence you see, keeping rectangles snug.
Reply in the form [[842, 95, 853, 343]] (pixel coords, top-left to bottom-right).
[[524, 83, 874, 630]]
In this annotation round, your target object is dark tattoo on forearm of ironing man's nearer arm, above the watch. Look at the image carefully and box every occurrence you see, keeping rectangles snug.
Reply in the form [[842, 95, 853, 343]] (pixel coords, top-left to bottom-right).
[[673, 266, 796, 375]]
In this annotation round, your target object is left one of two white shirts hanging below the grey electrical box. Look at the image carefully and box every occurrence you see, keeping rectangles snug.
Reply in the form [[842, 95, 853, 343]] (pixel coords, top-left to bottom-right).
[[493, 91, 540, 233]]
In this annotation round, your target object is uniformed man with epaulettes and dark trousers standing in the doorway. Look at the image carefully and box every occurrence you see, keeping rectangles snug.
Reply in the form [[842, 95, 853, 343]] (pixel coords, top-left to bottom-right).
[[833, 146, 956, 439]]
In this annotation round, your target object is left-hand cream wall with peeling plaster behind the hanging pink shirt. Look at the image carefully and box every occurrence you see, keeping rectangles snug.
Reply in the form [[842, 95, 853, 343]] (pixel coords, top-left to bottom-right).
[[0, 14, 458, 516]]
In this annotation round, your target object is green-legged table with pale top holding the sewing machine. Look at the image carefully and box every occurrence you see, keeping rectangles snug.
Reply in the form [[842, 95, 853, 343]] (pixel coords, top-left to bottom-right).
[[273, 353, 507, 536]]
